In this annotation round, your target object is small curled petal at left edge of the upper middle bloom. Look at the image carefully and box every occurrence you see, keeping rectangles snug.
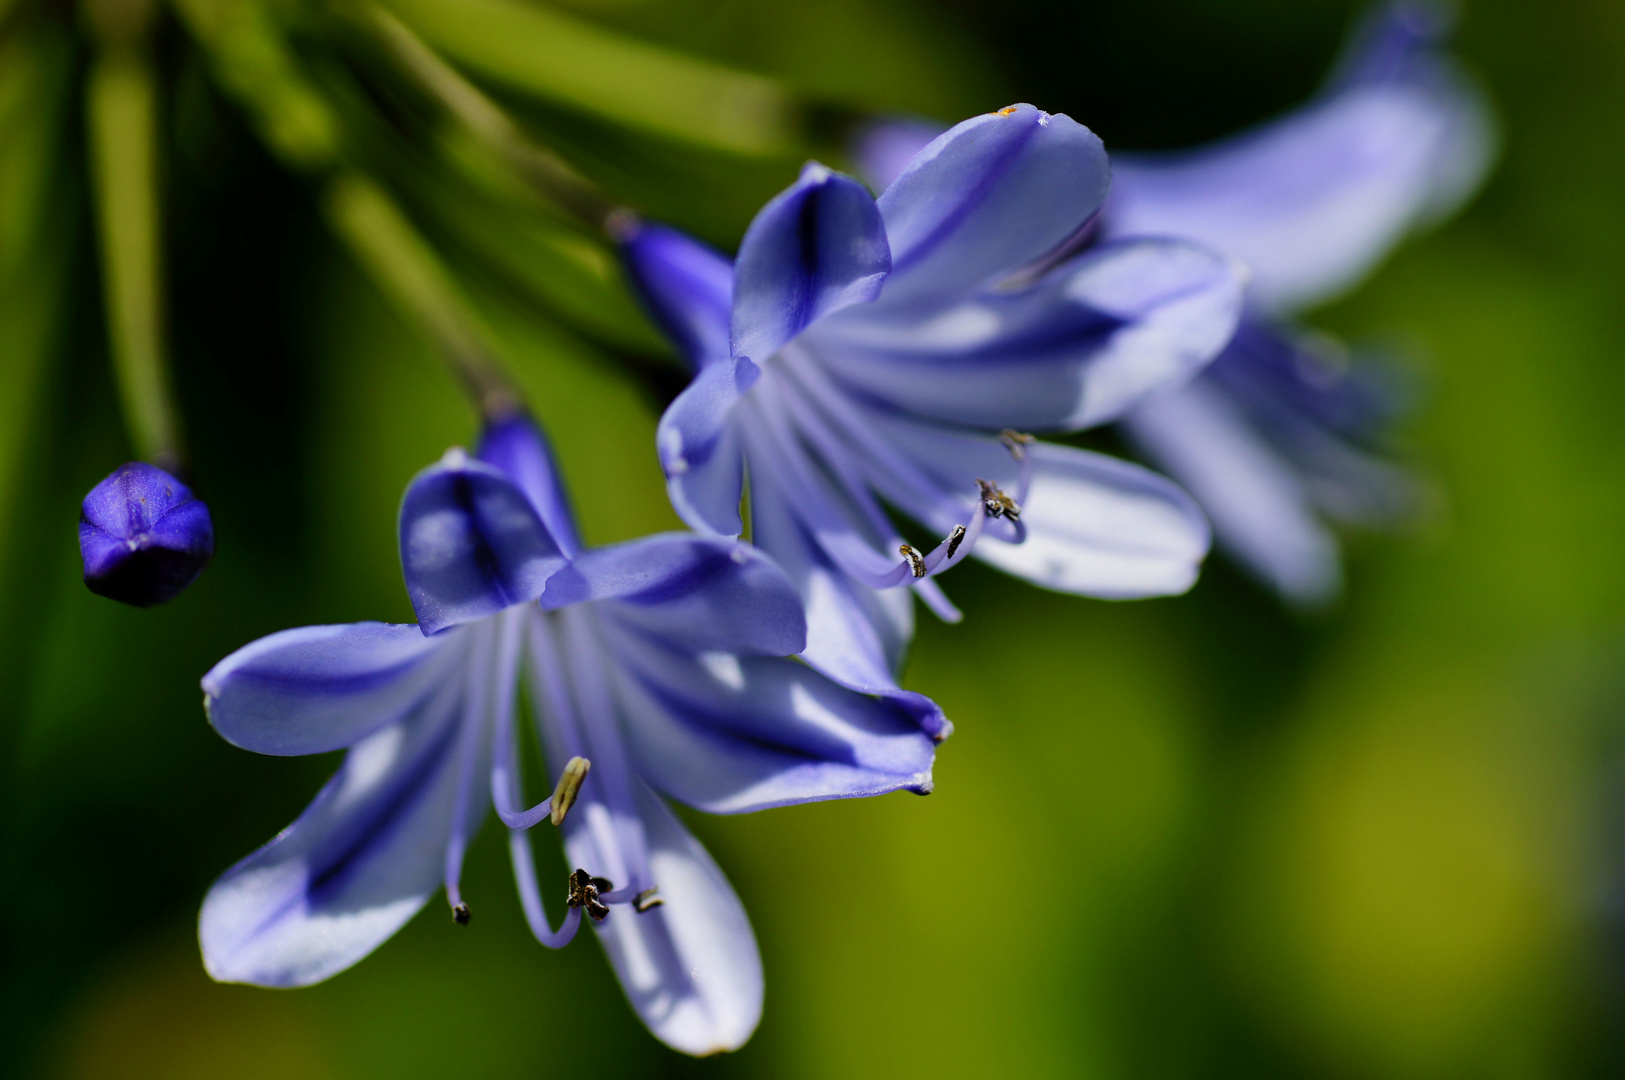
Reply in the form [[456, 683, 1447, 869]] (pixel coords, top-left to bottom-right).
[[655, 359, 762, 536]]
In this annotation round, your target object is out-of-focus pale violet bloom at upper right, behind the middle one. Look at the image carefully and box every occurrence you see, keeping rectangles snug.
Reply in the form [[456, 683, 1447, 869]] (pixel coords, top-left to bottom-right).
[[860, 2, 1493, 604]]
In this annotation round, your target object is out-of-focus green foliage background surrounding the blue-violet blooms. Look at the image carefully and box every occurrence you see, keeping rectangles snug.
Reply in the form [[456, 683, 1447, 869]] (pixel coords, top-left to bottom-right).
[[0, 0, 1625, 1078]]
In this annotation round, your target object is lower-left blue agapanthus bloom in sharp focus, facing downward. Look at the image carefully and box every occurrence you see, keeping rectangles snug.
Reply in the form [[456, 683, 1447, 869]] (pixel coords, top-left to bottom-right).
[[200, 410, 934, 1054]]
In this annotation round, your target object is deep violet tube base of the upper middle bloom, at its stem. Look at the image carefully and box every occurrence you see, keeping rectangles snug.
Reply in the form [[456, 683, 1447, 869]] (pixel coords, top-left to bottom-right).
[[621, 222, 733, 370]]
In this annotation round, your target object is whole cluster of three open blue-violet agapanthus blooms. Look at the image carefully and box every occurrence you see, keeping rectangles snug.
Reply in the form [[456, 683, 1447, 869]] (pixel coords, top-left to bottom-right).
[[196, 6, 1490, 1054]]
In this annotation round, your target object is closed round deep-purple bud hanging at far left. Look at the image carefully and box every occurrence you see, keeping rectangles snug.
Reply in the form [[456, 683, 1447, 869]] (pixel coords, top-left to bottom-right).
[[80, 461, 215, 607]]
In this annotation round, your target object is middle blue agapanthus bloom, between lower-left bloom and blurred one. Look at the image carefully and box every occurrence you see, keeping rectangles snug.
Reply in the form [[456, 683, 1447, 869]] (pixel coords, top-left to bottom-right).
[[624, 106, 1243, 731]]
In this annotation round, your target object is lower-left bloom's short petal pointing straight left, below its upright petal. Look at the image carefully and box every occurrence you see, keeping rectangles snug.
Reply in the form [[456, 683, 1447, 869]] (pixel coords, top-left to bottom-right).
[[203, 622, 447, 755]]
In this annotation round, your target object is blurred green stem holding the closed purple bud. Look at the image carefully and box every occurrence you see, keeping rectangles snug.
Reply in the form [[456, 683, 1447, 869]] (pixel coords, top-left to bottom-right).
[[86, 42, 180, 469]]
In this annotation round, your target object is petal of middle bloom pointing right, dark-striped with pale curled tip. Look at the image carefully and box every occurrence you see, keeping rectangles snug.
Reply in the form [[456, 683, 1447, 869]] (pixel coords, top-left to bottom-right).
[[806, 240, 1246, 430]]
